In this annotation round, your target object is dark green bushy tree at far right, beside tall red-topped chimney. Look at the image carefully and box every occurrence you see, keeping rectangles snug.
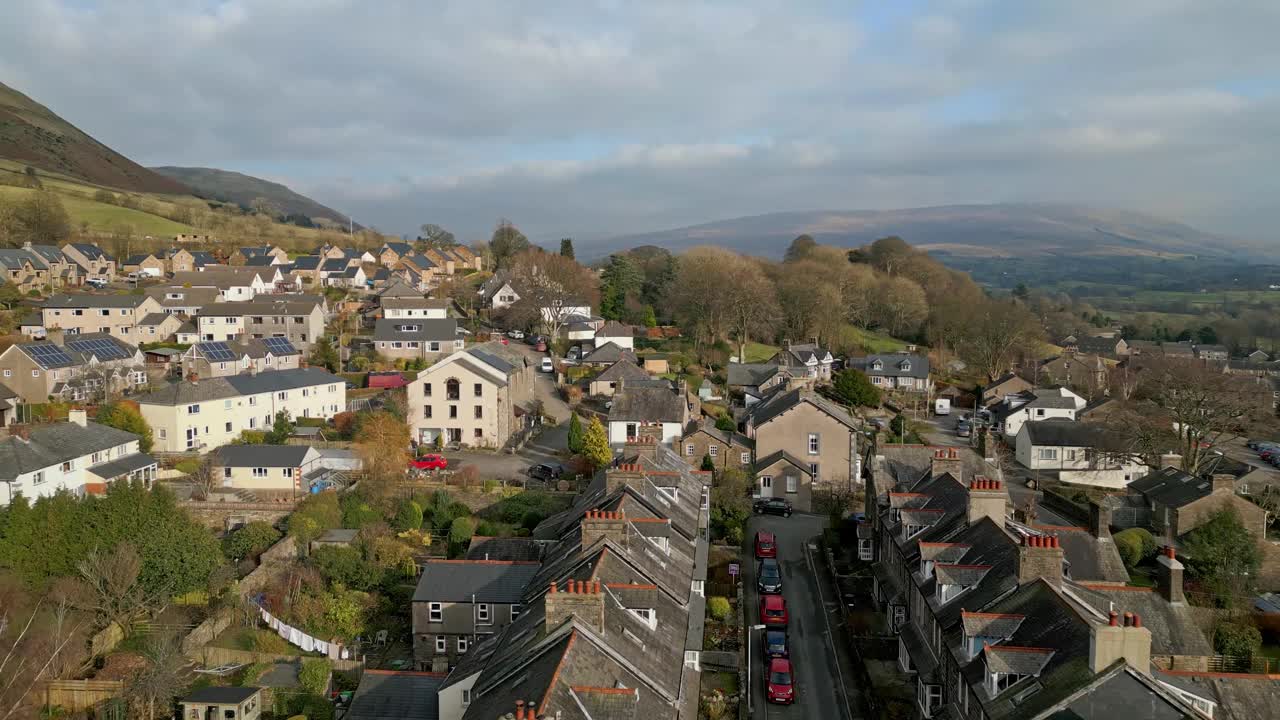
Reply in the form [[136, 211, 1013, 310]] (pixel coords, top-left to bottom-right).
[[1183, 506, 1262, 612]]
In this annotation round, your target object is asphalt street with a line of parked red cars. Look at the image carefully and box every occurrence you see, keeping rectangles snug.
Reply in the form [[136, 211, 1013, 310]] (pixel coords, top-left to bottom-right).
[[742, 514, 856, 720]]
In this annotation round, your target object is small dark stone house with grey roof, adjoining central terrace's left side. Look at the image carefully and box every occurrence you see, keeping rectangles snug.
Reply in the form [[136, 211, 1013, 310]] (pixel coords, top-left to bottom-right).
[[411, 560, 541, 667]]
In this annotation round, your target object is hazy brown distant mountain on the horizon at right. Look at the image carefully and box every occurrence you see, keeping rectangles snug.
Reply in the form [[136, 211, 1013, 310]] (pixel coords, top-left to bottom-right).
[[591, 204, 1277, 260]]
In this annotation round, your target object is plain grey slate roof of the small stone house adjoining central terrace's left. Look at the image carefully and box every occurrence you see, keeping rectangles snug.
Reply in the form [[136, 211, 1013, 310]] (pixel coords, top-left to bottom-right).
[[413, 560, 540, 605]]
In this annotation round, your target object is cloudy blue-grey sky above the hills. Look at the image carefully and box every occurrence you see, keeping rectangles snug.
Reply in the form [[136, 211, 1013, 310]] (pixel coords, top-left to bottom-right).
[[0, 0, 1280, 245]]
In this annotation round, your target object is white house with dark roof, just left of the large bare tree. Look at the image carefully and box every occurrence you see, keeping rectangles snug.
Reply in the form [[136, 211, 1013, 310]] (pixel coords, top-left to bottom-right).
[[1015, 419, 1147, 488]]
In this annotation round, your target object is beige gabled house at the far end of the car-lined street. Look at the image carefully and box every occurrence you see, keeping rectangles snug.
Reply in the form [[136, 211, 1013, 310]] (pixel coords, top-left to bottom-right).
[[746, 388, 861, 511]]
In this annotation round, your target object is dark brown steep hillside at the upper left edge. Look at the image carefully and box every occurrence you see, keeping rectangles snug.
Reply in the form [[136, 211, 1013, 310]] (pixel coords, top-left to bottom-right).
[[0, 83, 188, 195]]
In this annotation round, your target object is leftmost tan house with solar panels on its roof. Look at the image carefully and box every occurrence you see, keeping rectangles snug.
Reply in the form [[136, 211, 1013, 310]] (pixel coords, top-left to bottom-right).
[[0, 333, 147, 402]]
